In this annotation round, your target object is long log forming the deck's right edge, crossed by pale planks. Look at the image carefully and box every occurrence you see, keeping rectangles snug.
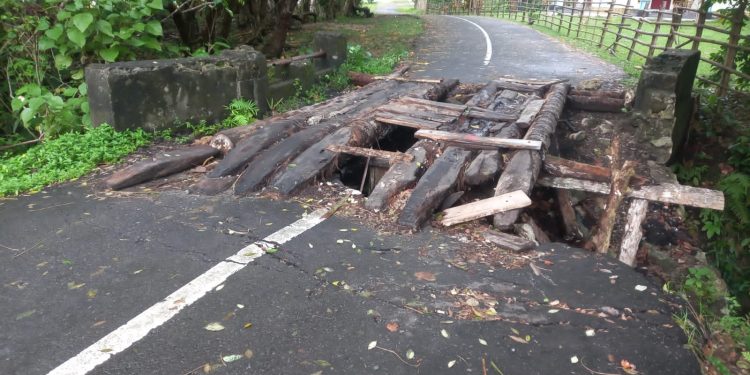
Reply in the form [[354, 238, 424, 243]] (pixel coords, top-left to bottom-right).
[[493, 83, 568, 229]]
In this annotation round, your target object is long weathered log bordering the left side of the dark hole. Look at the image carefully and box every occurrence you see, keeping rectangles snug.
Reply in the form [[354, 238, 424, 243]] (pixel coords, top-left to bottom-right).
[[272, 80, 456, 195]]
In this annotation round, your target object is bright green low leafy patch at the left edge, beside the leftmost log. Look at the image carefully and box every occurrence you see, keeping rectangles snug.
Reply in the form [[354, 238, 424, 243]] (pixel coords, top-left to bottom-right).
[[0, 125, 152, 196]]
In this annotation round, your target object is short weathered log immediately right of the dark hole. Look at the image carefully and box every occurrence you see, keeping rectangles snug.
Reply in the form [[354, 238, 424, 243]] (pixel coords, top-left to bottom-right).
[[365, 139, 439, 210]]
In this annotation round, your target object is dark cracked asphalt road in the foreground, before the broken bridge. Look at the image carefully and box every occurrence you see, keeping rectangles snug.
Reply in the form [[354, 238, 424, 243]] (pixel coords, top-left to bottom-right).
[[0, 14, 700, 375]]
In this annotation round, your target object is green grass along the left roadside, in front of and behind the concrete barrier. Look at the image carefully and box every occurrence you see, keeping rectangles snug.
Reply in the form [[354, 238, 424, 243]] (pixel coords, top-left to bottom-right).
[[0, 16, 422, 197]]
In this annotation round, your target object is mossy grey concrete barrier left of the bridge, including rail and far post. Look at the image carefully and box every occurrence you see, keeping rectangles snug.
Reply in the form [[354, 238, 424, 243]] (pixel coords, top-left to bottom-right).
[[86, 32, 346, 130]]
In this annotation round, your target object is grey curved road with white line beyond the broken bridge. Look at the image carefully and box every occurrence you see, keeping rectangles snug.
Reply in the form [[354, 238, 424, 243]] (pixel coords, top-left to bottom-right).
[[411, 16, 625, 83]]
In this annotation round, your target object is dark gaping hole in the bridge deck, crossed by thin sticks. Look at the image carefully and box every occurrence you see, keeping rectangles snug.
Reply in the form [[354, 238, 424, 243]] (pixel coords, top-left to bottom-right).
[[338, 126, 417, 196]]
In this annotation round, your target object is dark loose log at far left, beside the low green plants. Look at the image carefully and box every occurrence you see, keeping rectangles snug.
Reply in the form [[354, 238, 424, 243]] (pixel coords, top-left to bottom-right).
[[105, 145, 219, 190]]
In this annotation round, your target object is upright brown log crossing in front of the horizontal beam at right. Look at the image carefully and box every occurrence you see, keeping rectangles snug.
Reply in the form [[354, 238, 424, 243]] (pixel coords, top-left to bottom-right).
[[584, 160, 635, 254]]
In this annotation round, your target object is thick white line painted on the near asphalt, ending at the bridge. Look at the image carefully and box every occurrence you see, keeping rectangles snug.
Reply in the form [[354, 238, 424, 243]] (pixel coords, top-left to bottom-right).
[[48, 209, 329, 375]]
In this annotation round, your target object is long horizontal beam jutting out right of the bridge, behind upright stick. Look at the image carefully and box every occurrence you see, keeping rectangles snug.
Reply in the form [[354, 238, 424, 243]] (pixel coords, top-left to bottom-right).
[[537, 177, 724, 211]]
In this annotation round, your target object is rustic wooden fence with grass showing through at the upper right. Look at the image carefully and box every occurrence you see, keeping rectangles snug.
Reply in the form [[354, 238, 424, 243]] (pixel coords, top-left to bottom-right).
[[427, 0, 750, 96]]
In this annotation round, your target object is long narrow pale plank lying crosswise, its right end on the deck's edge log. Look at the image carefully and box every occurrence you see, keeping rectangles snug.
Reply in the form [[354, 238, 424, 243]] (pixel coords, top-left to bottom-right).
[[414, 129, 542, 150]]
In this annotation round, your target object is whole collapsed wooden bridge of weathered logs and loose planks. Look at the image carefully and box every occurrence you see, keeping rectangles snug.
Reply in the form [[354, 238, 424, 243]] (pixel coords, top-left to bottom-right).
[[106, 76, 724, 265]]
